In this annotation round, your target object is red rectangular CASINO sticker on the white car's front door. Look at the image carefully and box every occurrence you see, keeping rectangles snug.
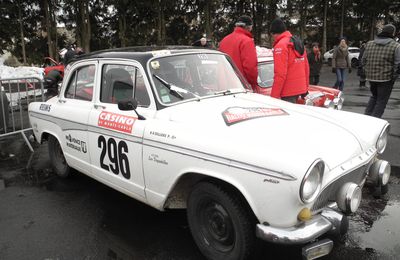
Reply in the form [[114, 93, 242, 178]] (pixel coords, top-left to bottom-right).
[[97, 111, 137, 133]]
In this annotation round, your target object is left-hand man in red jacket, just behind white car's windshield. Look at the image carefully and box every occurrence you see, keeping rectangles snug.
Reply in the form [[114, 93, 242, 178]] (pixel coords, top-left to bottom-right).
[[219, 15, 258, 91]]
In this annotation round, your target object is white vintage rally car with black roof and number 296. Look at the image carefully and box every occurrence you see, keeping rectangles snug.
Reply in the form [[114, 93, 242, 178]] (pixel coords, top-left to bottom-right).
[[29, 47, 390, 259]]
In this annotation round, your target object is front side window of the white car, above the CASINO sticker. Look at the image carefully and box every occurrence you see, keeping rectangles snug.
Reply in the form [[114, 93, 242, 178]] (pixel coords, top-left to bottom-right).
[[100, 64, 150, 107]]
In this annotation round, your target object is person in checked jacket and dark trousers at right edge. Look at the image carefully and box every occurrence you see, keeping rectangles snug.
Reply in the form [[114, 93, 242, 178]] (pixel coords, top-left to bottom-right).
[[362, 24, 400, 118]]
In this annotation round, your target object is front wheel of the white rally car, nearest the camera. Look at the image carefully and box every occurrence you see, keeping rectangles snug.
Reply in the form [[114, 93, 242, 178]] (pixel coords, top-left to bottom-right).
[[187, 182, 256, 260]]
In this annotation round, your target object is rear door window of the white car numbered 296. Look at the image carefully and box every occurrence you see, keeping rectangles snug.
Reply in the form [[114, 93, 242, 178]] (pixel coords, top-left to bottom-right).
[[65, 65, 96, 101]]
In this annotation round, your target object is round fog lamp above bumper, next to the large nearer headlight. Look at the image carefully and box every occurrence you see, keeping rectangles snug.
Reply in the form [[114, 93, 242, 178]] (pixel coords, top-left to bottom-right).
[[336, 182, 362, 214]]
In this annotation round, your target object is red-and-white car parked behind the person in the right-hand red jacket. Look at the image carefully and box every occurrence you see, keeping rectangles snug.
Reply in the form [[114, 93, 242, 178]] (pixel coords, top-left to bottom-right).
[[257, 46, 344, 110]]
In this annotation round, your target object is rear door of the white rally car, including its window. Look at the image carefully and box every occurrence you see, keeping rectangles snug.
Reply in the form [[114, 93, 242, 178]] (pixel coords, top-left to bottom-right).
[[52, 61, 97, 173]]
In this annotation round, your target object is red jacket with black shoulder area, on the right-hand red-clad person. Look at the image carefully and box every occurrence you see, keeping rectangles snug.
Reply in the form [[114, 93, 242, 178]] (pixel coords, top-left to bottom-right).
[[271, 31, 310, 98]]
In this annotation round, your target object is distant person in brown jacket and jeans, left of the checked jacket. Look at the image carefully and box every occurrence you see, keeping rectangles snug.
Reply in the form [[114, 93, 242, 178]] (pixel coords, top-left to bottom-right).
[[332, 37, 351, 91]]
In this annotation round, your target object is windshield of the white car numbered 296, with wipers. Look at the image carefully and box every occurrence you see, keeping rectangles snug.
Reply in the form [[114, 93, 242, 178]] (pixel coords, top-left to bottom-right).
[[150, 53, 246, 104]]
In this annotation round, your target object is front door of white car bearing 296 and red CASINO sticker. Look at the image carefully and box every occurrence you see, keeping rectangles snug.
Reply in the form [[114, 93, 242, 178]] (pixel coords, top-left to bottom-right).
[[89, 61, 155, 200]]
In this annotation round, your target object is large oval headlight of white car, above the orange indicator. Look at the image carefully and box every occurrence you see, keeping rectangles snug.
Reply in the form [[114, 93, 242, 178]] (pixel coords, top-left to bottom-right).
[[300, 159, 325, 203]]
